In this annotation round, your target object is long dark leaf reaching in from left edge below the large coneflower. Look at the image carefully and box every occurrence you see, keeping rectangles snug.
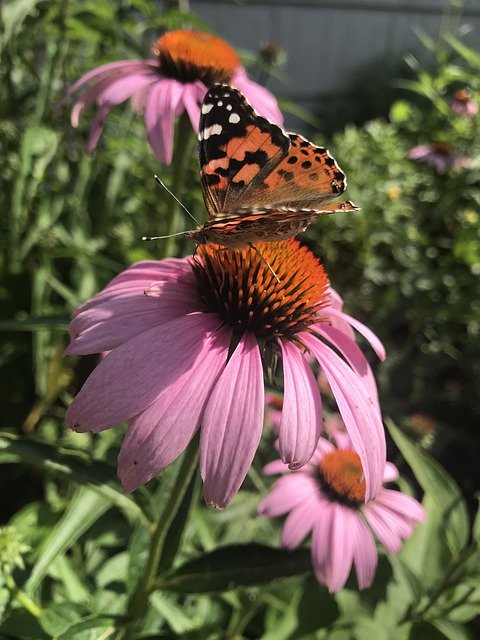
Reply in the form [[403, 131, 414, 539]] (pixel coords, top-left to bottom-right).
[[0, 432, 148, 526]]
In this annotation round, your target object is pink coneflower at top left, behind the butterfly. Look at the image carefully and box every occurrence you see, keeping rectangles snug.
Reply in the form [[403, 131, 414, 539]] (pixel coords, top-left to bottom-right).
[[63, 29, 282, 164]]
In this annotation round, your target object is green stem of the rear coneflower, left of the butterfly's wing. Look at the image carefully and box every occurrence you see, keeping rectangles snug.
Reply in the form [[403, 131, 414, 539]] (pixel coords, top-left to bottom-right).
[[163, 113, 194, 258]]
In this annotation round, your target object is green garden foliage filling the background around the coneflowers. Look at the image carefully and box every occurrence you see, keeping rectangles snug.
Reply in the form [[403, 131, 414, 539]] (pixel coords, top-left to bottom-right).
[[0, 0, 480, 640]]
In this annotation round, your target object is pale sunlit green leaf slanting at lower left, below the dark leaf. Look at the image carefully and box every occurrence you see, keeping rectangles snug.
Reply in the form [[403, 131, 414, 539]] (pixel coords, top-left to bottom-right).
[[25, 487, 112, 593]]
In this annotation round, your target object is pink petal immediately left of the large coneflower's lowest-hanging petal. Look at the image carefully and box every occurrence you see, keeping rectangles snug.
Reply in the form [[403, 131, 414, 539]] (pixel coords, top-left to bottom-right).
[[118, 328, 232, 491]]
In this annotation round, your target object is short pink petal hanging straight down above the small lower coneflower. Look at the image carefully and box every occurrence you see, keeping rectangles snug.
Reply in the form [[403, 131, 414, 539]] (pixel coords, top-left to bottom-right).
[[279, 340, 322, 469]]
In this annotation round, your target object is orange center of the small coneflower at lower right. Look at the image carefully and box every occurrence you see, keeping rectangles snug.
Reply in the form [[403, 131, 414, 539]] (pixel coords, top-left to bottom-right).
[[319, 449, 365, 507]]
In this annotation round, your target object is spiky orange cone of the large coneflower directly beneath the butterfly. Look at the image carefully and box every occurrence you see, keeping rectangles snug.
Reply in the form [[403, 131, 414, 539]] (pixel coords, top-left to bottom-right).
[[193, 240, 329, 340]]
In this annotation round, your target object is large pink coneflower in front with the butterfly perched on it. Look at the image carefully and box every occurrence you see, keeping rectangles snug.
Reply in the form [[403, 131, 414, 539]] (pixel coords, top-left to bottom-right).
[[66, 240, 385, 507]]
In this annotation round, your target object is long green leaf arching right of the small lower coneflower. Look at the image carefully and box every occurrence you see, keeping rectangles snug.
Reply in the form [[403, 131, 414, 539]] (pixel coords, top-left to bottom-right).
[[386, 420, 470, 554]]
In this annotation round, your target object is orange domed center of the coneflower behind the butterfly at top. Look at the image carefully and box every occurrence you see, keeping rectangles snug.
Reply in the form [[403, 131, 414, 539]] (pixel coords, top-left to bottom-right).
[[152, 29, 240, 86]]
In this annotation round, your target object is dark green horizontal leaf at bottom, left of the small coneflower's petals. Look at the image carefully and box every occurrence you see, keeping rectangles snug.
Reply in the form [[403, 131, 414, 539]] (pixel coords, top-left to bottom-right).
[[160, 544, 311, 593]]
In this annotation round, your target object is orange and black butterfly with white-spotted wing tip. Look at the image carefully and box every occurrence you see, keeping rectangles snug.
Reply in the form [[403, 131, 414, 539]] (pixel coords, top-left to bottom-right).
[[185, 84, 358, 249]]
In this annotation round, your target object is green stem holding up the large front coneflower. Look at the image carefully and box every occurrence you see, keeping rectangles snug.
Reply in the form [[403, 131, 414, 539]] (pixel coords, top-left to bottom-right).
[[125, 437, 198, 639]]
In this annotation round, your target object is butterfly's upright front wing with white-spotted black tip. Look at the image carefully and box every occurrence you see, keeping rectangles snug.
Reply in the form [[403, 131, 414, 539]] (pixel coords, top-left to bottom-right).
[[199, 84, 291, 216]]
